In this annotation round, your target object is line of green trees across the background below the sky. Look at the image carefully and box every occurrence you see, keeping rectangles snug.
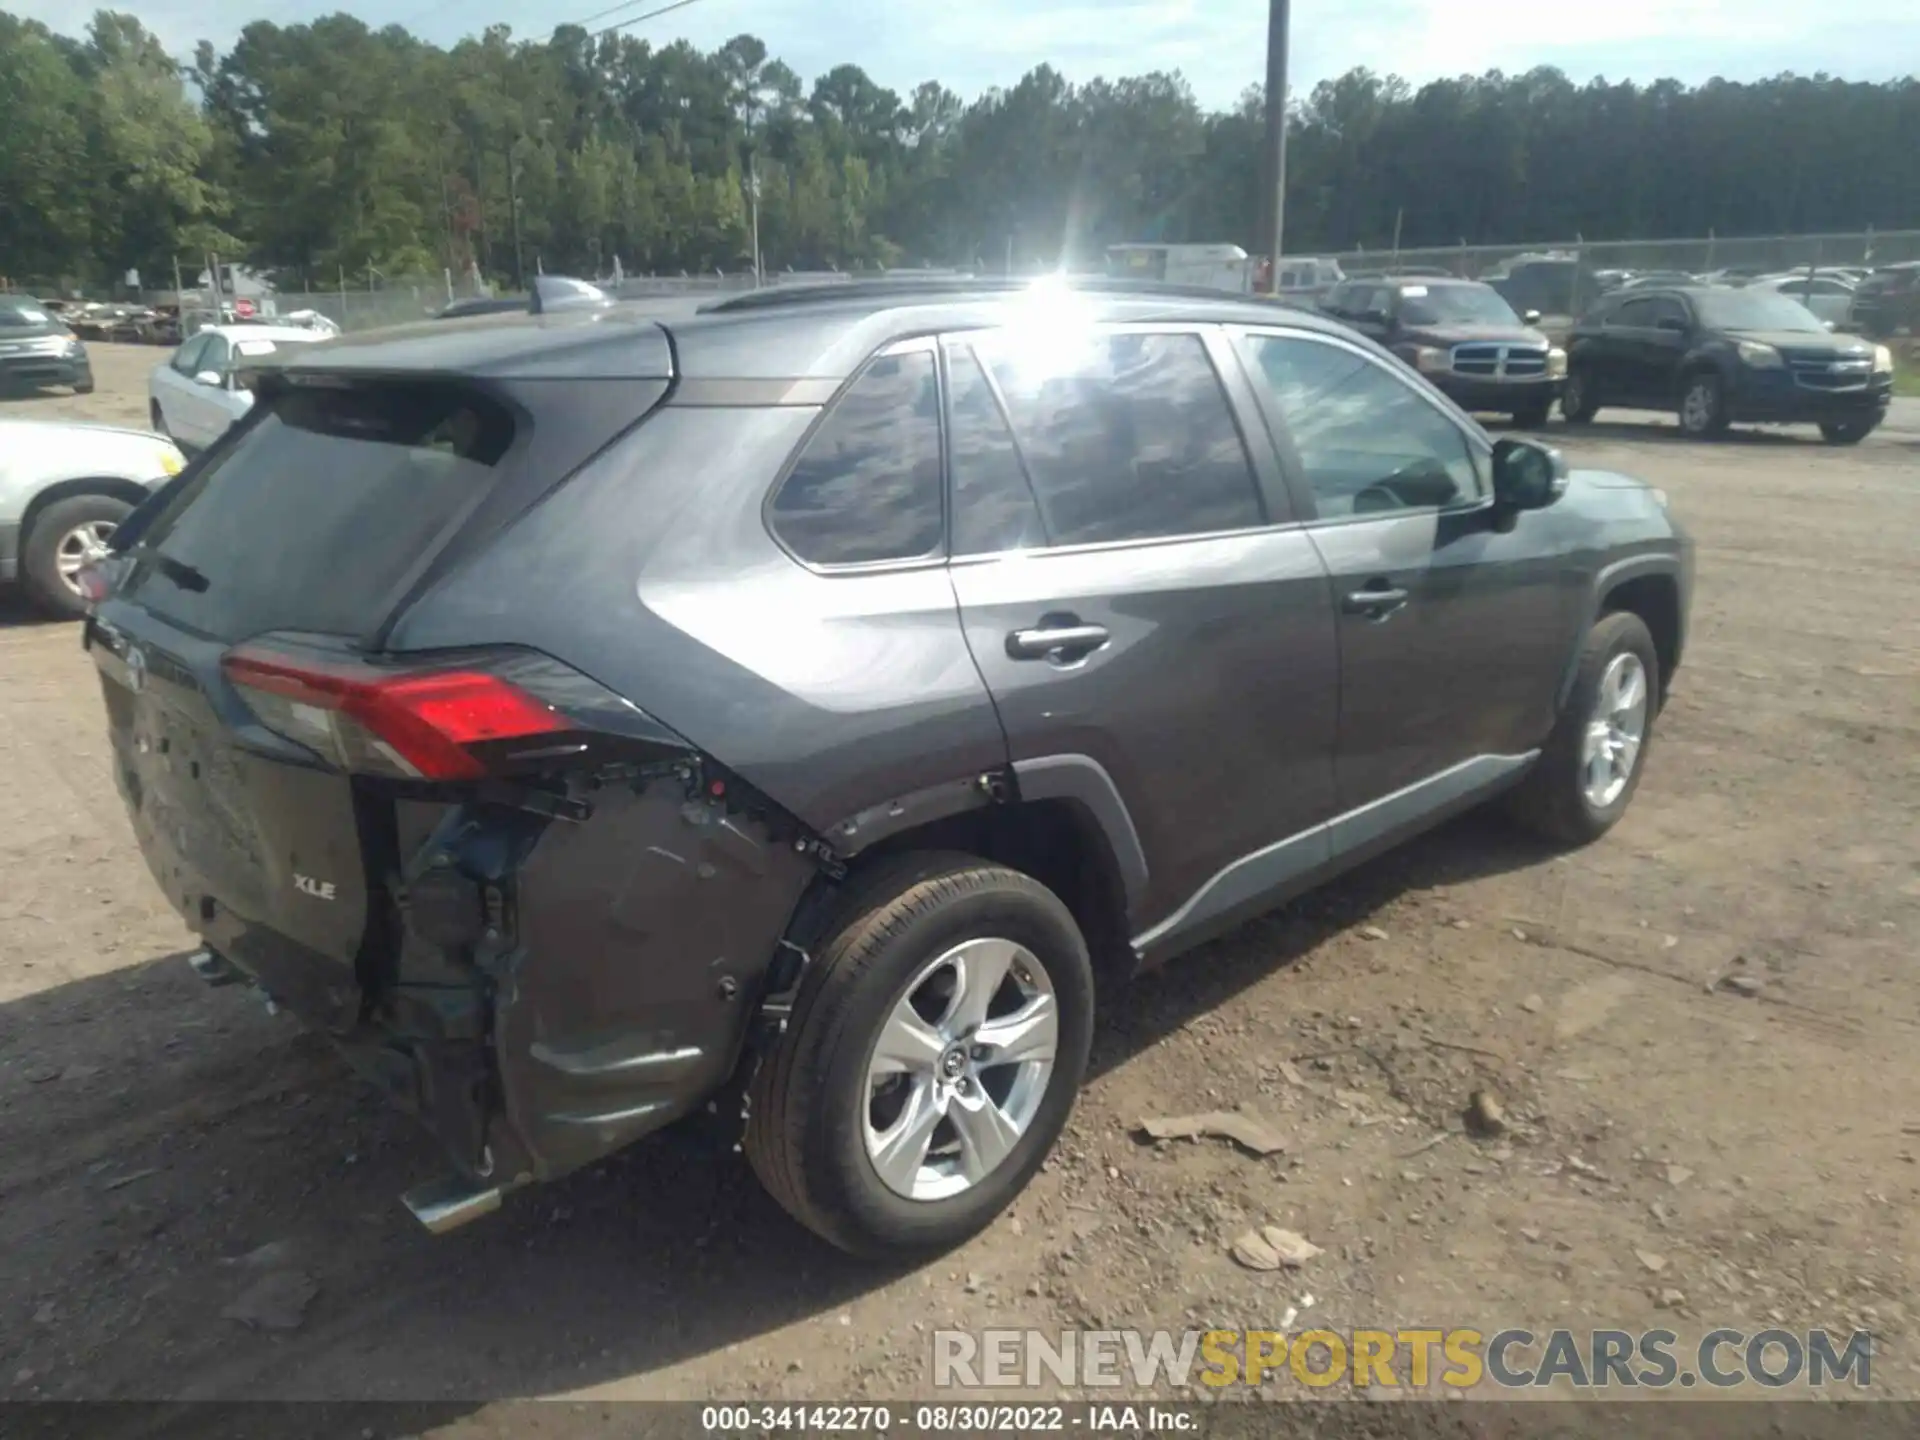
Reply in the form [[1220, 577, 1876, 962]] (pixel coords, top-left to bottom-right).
[[0, 12, 1920, 288]]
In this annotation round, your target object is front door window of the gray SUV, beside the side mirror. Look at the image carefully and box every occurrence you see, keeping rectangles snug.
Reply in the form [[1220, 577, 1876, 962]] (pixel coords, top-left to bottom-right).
[[1252, 336, 1480, 518]]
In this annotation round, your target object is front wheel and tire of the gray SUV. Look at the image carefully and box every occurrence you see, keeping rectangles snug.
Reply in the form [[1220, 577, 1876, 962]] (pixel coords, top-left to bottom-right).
[[1507, 611, 1661, 845]]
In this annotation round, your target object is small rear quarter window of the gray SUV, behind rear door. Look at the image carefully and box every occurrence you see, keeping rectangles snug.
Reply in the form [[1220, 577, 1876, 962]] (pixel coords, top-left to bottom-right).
[[774, 349, 941, 564]]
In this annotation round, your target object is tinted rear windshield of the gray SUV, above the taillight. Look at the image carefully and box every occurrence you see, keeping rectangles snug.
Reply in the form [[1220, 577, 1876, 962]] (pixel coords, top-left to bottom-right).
[[125, 382, 515, 639]]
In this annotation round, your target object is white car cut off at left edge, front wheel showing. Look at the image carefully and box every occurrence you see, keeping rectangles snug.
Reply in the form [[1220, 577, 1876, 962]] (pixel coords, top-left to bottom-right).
[[0, 420, 186, 614]]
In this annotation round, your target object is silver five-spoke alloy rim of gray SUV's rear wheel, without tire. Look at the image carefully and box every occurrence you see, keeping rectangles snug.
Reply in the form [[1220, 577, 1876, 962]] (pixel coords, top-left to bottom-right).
[[862, 939, 1060, 1200]]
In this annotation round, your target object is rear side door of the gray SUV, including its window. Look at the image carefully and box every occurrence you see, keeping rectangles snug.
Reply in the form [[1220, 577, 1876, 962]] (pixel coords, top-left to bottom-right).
[[945, 326, 1338, 947]]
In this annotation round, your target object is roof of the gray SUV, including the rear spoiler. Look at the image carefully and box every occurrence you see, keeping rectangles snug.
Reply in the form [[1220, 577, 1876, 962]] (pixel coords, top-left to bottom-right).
[[284, 276, 1348, 380]]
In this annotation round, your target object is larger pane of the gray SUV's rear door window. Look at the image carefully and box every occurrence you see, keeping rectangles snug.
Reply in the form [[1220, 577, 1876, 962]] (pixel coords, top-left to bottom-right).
[[975, 332, 1263, 545]]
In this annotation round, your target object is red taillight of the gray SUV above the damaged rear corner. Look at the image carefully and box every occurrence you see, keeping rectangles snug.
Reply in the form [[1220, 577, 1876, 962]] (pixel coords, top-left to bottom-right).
[[221, 645, 574, 780]]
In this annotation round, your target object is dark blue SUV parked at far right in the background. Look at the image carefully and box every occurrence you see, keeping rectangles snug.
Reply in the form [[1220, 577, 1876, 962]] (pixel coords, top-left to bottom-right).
[[1561, 286, 1893, 445]]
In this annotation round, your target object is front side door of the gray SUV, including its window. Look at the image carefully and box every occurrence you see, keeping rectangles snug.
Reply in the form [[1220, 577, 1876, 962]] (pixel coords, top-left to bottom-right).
[[1244, 330, 1580, 847]]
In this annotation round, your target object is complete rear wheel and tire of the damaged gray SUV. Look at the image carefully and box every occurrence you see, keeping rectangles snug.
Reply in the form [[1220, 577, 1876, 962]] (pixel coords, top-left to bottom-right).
[[745, 854, 1094, 1258]]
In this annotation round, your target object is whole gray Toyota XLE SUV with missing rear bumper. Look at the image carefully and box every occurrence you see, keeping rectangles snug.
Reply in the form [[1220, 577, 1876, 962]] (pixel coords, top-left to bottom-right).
[[86, 280, 1692, 1254]]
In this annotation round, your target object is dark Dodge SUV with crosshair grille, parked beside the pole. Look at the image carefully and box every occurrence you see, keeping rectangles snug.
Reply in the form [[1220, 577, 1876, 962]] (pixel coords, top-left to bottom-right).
[[1321, 275, 1567, 428]]
